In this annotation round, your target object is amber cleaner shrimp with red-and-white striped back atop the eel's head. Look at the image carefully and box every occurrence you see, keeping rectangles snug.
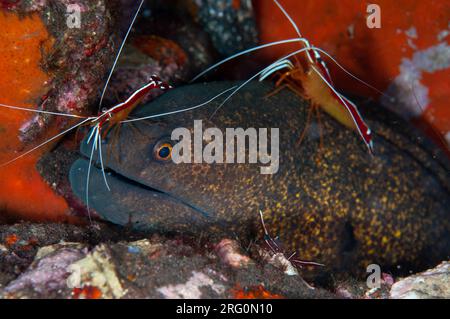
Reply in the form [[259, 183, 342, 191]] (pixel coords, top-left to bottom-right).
[[192, 0, 398, 154]]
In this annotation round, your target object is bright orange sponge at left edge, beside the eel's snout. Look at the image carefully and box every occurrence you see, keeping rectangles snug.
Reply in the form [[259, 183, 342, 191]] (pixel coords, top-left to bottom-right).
[[0, 12, 68, 221]]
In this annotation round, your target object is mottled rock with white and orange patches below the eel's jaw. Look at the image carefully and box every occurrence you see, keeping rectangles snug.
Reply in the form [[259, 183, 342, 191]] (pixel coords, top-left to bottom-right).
[[0, 224, 334, 298]]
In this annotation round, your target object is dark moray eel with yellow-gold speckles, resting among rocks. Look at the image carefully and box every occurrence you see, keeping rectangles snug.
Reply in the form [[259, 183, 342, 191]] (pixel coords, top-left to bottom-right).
[[70, 82, 450, 272]]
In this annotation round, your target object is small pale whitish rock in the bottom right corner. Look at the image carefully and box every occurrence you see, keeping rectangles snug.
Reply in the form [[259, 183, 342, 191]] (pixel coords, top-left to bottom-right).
[[390, 261, 450, 299]]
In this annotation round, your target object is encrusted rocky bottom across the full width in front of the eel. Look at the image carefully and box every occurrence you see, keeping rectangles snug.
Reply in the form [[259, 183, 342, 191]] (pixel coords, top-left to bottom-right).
[[0, 224, 450, 299]]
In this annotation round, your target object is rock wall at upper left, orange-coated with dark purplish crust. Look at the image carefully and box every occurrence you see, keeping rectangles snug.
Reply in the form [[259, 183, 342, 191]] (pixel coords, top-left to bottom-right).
[[0, 0, 118, 221]]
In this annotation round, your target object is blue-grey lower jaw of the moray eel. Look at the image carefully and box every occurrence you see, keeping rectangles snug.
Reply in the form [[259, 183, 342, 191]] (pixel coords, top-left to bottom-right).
[[69, 157, 214, 231]]
